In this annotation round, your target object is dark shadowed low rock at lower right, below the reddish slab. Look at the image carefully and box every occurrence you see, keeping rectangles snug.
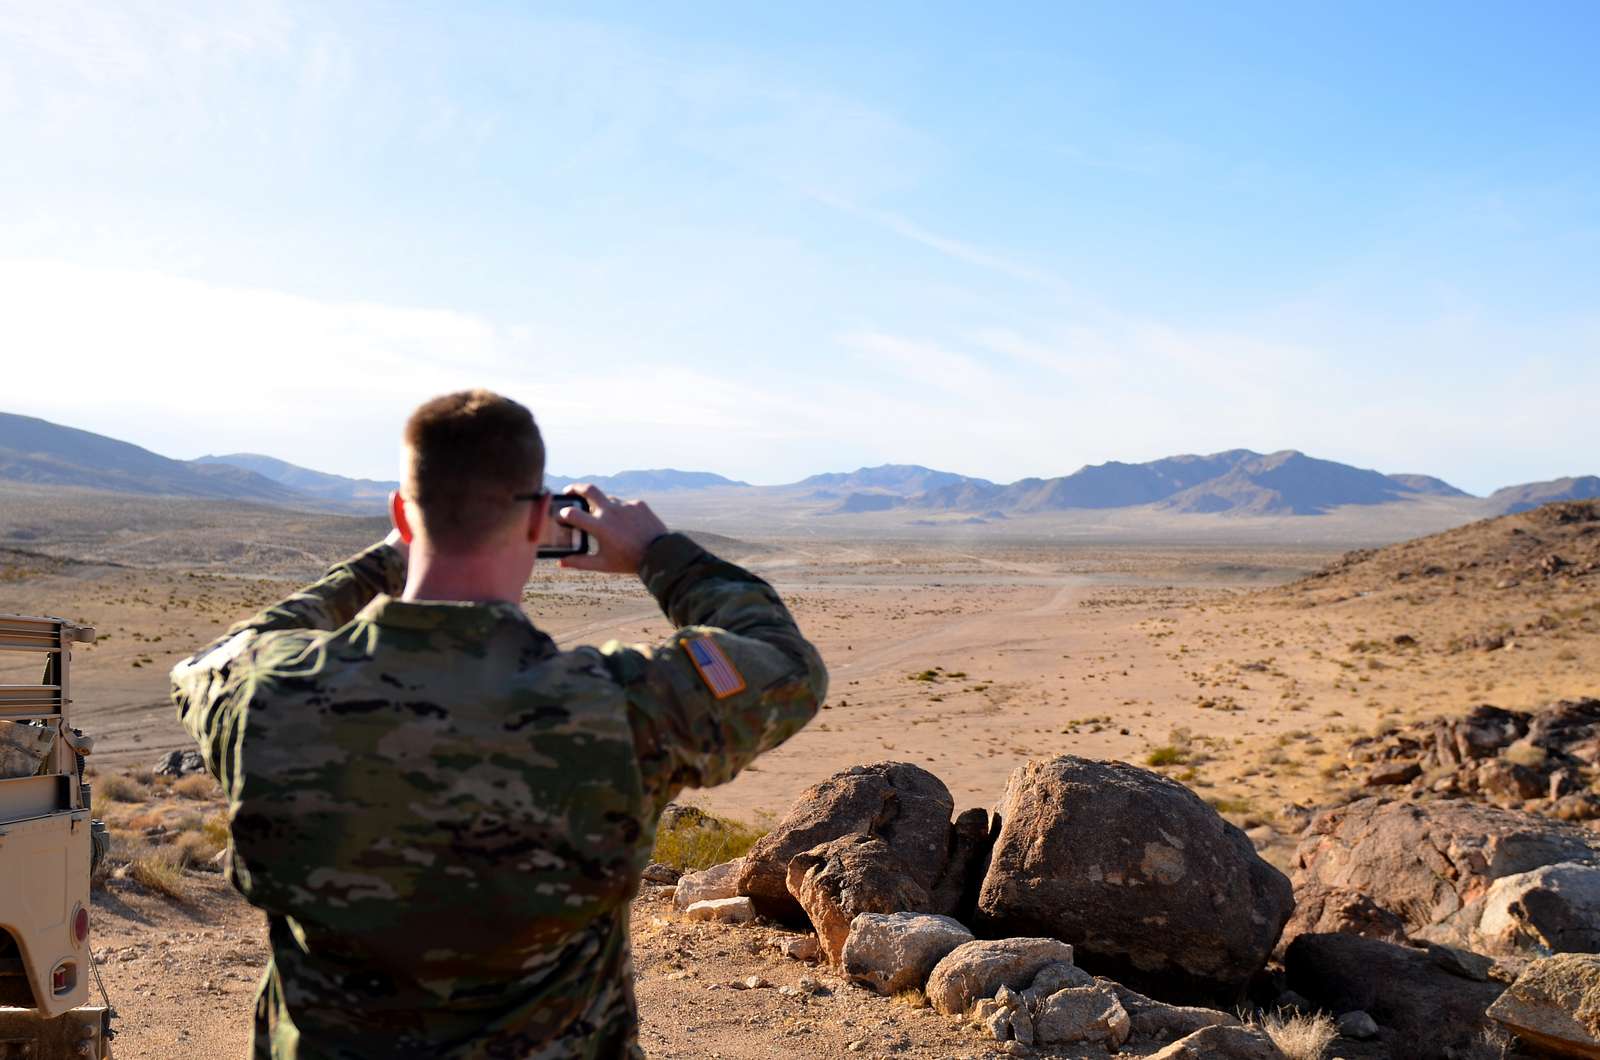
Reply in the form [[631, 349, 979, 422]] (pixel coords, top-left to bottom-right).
[[1283, 935, 1504, 1060]]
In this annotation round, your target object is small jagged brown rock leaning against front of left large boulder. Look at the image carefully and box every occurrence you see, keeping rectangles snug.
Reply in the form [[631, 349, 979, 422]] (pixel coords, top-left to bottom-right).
[[787, 833, 928, 964]]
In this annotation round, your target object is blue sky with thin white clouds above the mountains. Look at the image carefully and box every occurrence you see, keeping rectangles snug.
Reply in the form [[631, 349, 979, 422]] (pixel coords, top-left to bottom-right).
[[0, 0, 1600, 492]]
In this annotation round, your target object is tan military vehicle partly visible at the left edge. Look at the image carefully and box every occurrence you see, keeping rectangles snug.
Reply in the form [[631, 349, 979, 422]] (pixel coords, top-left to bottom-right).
[[0, 615, 114, 1060]]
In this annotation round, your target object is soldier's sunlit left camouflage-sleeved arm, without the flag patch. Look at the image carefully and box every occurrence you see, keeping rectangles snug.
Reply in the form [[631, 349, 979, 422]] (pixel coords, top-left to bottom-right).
[[171, 543, 405, 785]]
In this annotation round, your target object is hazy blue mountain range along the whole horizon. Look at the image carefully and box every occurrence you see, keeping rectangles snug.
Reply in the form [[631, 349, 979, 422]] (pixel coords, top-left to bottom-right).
[[0, 413, 1600, 516]]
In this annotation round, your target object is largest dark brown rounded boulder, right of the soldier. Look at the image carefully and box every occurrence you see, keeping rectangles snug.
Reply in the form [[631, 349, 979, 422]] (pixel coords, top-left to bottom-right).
[[976, 756, 1294, 1002]]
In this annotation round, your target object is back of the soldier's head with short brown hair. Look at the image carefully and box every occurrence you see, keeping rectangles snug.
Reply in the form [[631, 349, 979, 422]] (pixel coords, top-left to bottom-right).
[[402, 391, 544, 549]]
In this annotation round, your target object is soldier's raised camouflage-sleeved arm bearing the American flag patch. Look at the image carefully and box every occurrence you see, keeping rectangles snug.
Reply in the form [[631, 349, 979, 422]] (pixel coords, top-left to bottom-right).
[[602, 533, 827, 805]]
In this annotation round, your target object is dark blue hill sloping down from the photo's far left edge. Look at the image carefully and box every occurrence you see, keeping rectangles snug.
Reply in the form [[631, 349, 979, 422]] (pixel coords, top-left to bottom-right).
[[0, 413, 307, 504]]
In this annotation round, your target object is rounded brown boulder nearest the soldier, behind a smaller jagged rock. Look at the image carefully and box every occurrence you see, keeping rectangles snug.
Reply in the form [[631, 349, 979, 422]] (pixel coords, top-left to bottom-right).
[[738, 762, 955, 924]]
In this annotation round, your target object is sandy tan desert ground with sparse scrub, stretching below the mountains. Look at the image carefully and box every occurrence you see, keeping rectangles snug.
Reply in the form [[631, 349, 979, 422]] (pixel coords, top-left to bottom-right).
[[0, 490, 1600, 1057]]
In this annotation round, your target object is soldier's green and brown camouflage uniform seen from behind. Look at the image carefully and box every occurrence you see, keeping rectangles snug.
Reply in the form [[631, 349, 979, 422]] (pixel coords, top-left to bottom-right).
[[173, 535, 827, 1060]]
